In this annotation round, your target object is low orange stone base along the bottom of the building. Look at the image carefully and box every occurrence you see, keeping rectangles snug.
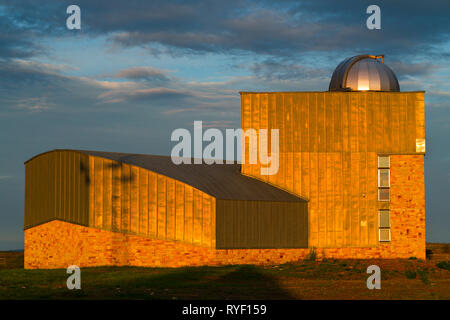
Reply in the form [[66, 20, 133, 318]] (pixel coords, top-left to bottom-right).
[[25, 220, 425, 269]]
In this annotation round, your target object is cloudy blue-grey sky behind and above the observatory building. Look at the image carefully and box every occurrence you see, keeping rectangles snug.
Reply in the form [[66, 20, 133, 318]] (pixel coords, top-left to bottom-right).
[[0, 0, 450, 250]]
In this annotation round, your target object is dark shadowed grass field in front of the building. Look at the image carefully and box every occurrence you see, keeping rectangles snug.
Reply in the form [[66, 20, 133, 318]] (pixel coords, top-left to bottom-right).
[[0, 252, 450, 299]]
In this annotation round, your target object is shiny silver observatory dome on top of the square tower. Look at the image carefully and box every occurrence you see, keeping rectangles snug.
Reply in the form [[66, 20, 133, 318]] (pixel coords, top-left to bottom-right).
[[329, 54, 400, 91]]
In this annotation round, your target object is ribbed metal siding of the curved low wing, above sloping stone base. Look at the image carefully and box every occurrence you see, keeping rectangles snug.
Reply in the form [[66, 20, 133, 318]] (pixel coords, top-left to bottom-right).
[[24, 151, 220, 247]]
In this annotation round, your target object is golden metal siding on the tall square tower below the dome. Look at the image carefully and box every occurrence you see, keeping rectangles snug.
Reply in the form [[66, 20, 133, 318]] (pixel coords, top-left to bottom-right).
[[241, 92, 424, 247]]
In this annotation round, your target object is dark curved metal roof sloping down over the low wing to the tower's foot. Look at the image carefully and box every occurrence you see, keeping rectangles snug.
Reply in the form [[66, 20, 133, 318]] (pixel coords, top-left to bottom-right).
[[27, 150, 306, 202]]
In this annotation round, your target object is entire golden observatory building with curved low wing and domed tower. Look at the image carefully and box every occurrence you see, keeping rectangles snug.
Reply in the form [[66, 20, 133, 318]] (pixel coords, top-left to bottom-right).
[[24, 55, 425, 268]]
